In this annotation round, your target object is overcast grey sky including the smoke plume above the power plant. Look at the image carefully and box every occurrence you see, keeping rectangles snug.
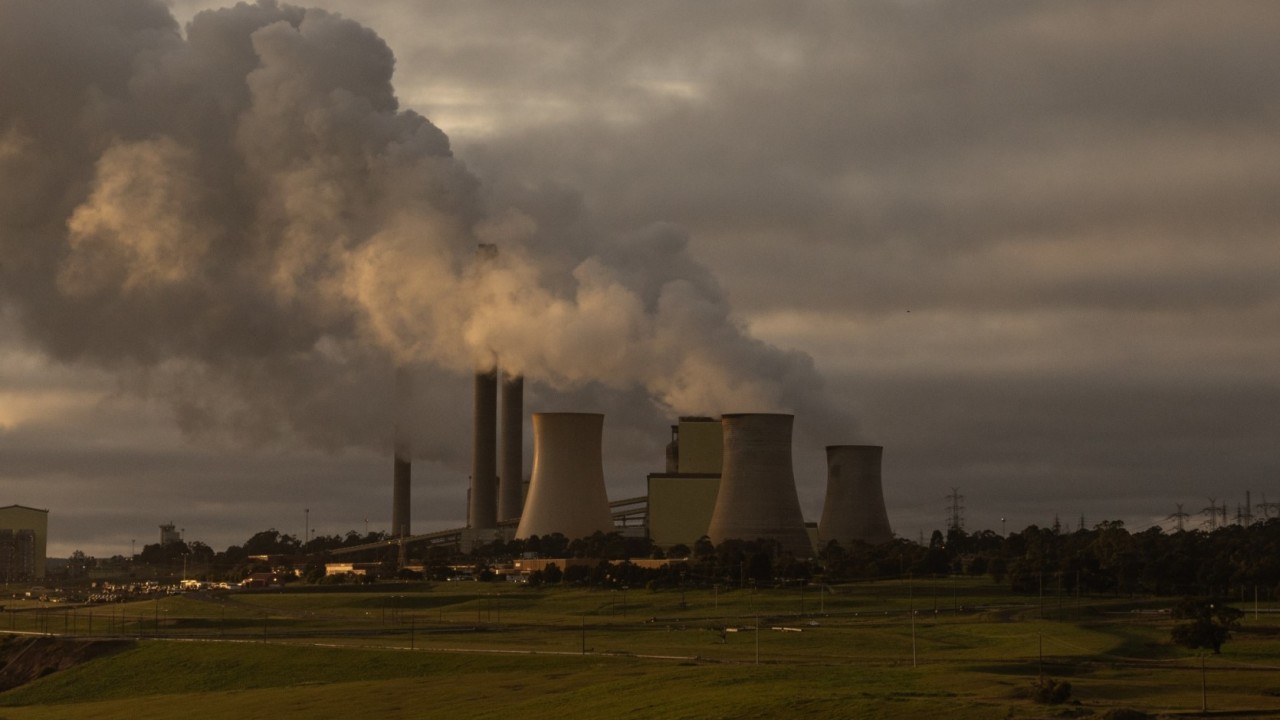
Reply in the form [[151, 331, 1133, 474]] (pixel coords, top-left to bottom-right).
[[0, 0, 1280, 556]]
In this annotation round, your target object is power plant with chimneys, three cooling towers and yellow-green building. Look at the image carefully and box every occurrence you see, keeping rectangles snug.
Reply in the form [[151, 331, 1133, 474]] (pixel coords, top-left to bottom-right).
[[373, 381, 893, 561]]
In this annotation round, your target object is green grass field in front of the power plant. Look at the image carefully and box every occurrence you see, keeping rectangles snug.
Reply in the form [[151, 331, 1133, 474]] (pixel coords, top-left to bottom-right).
[[0, 580, 1280, 720]]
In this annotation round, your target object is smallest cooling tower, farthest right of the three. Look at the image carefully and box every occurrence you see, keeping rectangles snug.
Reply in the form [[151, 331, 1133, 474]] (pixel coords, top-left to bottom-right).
[[818, 445, 893, 547]]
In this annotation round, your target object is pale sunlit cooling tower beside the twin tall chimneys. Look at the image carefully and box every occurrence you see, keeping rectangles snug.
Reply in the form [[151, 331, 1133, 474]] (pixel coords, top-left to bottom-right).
[[516, 413, 613, 539]]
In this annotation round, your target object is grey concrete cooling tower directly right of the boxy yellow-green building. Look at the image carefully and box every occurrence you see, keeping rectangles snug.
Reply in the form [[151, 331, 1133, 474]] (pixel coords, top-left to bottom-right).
[[707, 413, 813, 557]]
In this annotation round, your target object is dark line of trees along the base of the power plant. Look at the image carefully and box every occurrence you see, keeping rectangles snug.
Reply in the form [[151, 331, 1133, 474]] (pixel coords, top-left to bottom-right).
[[77, 519, 1280, 600]]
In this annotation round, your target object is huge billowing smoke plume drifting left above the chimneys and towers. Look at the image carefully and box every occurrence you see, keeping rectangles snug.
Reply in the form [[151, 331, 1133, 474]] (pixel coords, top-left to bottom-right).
[[0, 0, 849, 455]]
